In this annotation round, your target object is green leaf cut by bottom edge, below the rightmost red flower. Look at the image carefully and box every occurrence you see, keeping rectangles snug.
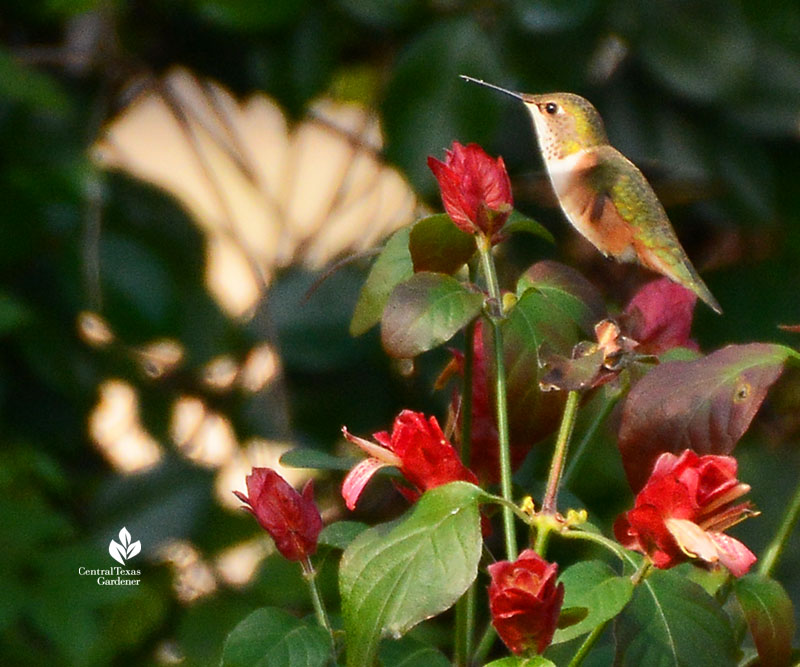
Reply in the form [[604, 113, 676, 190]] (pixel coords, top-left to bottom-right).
[[614, 570, 737, 667]]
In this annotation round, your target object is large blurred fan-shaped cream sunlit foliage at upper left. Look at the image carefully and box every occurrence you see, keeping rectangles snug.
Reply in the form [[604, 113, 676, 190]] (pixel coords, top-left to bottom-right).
[[91, 67, 417, 316]]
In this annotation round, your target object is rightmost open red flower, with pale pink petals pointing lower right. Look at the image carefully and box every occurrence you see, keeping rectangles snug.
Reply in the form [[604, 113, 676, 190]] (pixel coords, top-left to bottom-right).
[[614, 449, 756, 577]]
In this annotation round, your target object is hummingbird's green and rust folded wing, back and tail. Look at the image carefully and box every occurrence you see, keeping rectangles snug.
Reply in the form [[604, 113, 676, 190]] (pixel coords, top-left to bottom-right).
[[584, 145, 722, 313]]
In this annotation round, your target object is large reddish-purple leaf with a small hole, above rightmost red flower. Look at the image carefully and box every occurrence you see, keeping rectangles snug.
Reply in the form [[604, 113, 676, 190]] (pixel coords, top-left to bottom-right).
[[619, 343, 795, 492]]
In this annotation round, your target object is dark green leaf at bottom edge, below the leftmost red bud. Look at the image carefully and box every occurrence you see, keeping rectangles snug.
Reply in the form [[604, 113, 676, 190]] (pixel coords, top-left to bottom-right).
[[221, 607, 331, 667]]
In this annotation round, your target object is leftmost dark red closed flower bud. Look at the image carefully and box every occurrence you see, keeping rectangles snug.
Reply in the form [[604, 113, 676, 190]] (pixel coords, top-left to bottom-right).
[[233, 468, 322, 561]]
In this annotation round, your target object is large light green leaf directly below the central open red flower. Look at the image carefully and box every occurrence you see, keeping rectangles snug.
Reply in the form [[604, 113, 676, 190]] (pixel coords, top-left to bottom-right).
[[339, 482, 483, 667]]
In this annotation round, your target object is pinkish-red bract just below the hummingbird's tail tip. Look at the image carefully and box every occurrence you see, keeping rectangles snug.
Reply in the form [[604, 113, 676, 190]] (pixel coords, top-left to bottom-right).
[[623, 278, 697, 354]]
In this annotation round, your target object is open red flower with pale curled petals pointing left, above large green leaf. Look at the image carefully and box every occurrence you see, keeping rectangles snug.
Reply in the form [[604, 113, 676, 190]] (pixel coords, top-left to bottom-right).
[[342, 410, 478, 510]]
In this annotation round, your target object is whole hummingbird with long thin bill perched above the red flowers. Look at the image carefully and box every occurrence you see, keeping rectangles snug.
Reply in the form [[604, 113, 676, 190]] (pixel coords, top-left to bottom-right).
[[461, 74, 722, 314]]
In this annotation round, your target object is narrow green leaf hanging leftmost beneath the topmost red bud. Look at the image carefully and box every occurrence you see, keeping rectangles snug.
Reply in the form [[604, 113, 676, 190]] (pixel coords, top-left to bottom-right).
[[350, 227, 414, 336]]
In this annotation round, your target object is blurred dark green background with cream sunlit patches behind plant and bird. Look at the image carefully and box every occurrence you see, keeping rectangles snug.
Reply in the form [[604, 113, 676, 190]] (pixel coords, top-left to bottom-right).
[[0, 0, 800, 665]]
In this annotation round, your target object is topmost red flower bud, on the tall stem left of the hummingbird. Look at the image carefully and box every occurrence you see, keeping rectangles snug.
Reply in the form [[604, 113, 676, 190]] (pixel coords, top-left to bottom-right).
[[428, 141, 514, 243]]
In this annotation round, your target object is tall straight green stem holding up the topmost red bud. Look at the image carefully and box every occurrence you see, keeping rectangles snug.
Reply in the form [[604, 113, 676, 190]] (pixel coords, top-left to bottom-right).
[[478, 237, 517, 561]]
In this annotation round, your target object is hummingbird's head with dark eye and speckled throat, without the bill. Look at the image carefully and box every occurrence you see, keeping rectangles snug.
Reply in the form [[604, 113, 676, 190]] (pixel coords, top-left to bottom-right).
[[520, 93, 608, 160]]
